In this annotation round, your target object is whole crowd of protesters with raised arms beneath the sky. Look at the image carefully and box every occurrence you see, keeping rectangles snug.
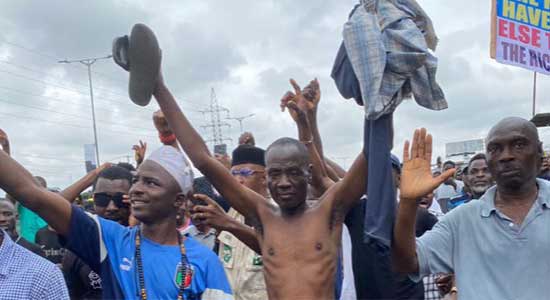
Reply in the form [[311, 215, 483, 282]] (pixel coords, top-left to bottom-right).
[[0, 7, 550, 300]]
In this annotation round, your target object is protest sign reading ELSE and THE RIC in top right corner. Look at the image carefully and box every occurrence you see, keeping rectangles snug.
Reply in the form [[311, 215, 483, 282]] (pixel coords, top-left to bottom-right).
[[491, 0, 550, 74]]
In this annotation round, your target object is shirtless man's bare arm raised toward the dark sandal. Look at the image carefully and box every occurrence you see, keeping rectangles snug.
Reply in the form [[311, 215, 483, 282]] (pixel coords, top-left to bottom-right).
[[154, 75, 267, 218]]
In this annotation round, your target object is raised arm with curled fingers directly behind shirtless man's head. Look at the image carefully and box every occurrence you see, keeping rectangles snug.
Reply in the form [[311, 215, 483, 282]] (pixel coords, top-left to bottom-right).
[[281, 79, 334, 194]]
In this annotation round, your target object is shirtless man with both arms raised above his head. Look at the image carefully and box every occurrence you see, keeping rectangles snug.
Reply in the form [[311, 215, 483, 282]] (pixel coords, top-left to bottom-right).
[[150, 70, 367, 299]]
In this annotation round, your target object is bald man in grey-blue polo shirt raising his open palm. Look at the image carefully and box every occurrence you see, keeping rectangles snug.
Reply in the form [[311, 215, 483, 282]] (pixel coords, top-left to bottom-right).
[[392, 118, 550, 299]]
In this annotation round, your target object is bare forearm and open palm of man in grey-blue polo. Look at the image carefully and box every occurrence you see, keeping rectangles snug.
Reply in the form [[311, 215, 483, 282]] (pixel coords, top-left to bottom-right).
[[392, 128, 454, 273]]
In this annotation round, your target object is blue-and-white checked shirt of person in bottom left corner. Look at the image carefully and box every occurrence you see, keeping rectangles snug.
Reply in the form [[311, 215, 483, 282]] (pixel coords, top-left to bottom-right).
[[0, 229, 69, 300]]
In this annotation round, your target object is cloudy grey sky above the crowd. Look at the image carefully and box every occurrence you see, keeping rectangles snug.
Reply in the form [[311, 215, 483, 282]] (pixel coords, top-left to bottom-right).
[[0, 0, 550, 187]]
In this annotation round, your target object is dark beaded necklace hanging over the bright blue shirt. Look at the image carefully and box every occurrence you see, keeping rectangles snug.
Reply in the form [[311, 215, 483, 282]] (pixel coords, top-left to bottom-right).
[[135, 229, 193, 300]]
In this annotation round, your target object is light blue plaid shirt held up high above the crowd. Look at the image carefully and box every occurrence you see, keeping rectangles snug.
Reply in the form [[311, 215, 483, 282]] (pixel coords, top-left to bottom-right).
[[344, 0, 447, 120]]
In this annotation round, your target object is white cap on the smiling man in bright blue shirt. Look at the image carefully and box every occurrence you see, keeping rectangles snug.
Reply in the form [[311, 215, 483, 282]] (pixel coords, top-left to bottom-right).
[[147, 146, 194, 194]]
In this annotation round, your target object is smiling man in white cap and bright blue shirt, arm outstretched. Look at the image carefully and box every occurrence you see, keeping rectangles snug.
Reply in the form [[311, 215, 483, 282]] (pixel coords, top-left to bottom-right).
[[0, 146, 232, 299]]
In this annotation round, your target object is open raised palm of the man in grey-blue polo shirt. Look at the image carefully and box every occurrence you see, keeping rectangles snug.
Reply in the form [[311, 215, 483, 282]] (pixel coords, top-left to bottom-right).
[[399, 128, 455, 202]]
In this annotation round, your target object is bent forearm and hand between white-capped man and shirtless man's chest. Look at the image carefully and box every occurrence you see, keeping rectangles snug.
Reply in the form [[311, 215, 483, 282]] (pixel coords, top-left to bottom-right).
[[193, 194, 262, 254]]
